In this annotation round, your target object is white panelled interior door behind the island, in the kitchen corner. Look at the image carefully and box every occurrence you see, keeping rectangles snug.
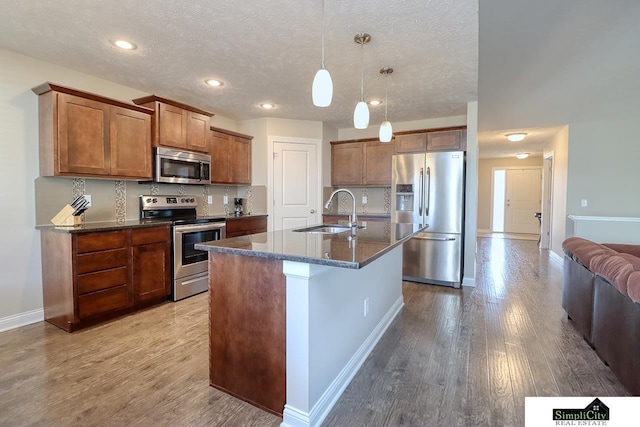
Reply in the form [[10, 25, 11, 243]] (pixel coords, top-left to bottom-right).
[[273, 141, 320, 230]]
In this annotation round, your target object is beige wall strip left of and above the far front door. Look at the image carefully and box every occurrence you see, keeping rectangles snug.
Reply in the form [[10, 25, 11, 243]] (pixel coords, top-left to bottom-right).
[[478, 156, 542, 230]]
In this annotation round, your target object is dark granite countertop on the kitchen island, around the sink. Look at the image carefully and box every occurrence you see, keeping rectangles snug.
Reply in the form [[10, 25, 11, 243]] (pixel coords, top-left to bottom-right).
[[195, 221, 427, 269]]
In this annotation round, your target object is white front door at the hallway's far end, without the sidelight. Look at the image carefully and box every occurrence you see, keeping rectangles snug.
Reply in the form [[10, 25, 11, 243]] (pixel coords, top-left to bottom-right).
[[504, 168, 542, 234]]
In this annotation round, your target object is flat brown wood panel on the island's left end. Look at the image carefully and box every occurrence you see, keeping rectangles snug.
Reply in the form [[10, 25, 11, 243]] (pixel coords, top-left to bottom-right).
[[209, 252, 286, 416]]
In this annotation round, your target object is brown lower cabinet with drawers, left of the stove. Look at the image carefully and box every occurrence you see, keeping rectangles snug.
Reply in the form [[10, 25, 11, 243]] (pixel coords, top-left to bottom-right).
[[41, 226, 171, 332]]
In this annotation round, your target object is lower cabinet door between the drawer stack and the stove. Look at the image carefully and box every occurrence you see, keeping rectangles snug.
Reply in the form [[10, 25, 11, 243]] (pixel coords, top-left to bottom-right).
[[132, 242, 171, 302]]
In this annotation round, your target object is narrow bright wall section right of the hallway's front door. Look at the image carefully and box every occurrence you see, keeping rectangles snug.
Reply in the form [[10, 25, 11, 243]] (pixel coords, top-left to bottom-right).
[[544, 126, 569, 257]]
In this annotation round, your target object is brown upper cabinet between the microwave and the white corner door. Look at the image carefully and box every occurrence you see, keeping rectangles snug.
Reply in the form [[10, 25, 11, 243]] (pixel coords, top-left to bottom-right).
[[209, 127, 253, 184]]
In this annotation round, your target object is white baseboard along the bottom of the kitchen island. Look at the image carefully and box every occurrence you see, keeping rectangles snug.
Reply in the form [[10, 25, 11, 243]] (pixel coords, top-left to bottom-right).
[[280, 296, 404, 427]]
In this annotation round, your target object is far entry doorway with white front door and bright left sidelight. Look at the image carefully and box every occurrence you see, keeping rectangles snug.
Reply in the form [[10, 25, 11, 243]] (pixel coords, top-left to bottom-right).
[[491, 166, 542, 234]]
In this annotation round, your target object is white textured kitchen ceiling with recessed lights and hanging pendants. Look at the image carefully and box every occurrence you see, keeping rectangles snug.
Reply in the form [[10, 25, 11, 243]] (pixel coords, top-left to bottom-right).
[[0, 0, 478, 128]]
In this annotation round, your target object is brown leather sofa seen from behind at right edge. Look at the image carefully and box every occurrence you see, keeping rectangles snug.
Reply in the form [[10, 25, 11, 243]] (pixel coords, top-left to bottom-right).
[[562, 237, 640, 395]]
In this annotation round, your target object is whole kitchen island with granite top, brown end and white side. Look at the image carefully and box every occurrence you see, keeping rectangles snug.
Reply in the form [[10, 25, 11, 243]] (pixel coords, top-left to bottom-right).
[[196, 222, 426, 426]]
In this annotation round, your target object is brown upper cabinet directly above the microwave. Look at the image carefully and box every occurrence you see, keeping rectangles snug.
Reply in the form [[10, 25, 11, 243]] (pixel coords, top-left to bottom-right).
[[133, 95, 213, 153]]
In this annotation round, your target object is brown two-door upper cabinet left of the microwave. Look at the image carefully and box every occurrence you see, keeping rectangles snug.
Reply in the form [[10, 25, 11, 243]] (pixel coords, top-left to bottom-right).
[[33, 83, 153, 180]]
